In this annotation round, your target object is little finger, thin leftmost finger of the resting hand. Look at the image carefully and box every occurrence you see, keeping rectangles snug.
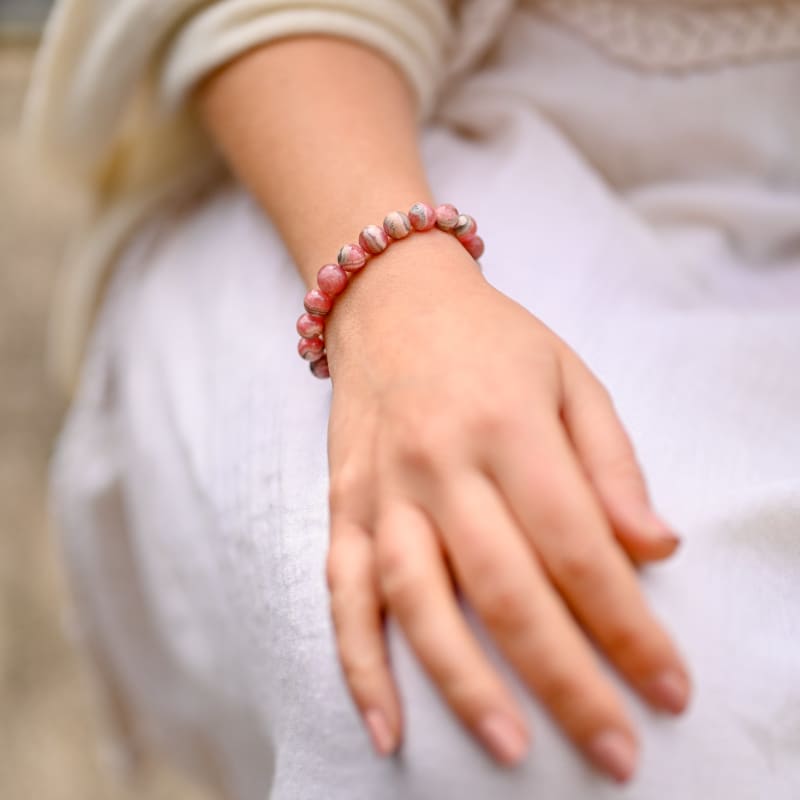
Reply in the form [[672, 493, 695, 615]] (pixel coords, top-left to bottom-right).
[[327, 516, 402, 755]]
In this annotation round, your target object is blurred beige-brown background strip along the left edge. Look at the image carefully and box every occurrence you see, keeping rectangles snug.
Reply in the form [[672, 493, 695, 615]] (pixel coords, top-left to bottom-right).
[[0, 0, 211, 800]]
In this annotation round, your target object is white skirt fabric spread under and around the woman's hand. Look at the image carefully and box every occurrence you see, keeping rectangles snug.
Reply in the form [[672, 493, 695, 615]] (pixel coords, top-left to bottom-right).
[[53, 7, 800, 800]]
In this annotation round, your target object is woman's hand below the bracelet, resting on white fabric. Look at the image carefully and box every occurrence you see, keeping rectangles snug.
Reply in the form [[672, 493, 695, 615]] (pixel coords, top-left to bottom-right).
[[327, 232, 689, 780]]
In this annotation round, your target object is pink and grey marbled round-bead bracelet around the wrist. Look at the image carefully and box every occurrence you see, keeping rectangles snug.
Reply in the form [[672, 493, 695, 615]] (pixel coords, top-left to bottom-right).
[[297, 203, 484, 378]]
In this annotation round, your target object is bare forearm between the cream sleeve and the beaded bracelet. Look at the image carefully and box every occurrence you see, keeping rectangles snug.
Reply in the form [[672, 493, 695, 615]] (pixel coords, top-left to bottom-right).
[[199, 36, 440, 286]]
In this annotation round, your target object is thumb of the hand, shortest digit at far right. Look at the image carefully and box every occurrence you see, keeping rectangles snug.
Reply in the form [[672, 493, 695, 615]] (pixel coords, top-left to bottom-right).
[[562, 359, 680, 561]]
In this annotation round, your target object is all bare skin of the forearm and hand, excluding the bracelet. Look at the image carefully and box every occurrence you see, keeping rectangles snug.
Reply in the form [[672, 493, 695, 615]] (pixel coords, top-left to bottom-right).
[[198, 36, 690, 781]]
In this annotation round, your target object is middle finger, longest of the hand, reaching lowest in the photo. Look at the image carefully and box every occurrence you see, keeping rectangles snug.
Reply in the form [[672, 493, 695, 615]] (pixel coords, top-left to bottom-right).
[[424, 473, 637, 781]]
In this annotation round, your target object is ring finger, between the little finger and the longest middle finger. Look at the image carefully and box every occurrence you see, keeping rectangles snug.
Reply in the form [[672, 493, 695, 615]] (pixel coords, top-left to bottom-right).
[[375, 501, 528, 766]]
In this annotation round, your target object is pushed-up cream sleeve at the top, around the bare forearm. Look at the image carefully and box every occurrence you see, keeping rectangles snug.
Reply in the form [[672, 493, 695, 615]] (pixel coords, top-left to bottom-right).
[[25, 0, 455, 177]]
